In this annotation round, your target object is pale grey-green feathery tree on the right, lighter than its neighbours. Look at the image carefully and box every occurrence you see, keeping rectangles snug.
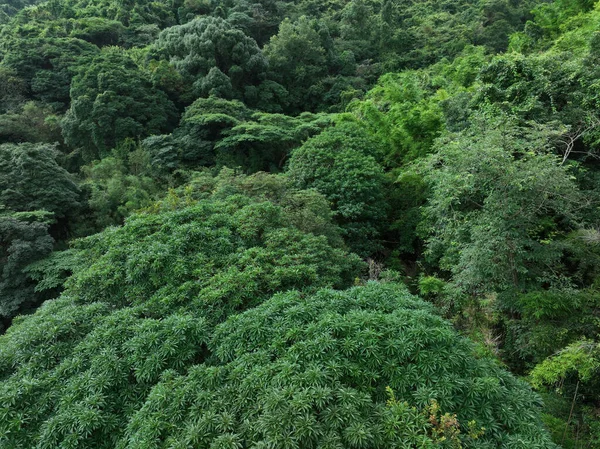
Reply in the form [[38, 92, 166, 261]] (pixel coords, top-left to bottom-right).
[[424, 117, 585, 295]]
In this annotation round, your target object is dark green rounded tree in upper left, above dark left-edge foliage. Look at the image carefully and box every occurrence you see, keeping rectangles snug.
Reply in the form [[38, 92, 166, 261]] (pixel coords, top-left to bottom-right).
[[63, 48, 176, 162]]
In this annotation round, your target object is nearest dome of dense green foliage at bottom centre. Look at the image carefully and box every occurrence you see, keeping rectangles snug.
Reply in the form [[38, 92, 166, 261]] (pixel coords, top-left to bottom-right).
[[124, 283, 555, 449]]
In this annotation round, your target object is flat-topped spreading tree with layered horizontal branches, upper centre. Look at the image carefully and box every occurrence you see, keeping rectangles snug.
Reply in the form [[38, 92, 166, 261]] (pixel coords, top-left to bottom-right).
[[143, 96, 334, 177]]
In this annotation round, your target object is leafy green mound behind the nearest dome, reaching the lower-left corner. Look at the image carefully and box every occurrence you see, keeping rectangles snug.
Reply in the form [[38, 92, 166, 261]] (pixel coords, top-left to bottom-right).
[[0, 174, 360, 449]]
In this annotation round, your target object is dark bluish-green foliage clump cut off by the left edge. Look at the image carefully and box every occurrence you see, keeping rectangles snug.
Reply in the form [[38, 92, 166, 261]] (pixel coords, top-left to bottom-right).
[[0, 143, 81, 321]]
